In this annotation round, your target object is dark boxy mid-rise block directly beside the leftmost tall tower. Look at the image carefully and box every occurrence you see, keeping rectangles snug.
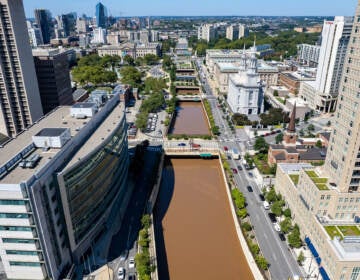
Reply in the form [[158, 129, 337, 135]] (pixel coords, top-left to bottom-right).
[[32, 49, 74, 114]]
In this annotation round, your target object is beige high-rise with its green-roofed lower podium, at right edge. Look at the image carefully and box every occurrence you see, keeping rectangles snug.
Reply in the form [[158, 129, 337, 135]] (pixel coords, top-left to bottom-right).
[[275, 5, 360, 280]]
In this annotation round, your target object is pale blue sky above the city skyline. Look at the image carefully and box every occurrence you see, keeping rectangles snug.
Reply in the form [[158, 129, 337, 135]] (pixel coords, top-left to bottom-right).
[[23, 0, 357, 17]]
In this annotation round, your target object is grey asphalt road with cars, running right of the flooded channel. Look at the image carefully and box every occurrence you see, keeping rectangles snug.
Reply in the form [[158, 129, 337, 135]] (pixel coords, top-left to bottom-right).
[[203, 61, 302, 280]]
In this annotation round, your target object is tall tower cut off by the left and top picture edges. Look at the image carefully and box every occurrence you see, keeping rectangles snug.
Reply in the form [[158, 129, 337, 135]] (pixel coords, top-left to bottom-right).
[[0, 0, 43, 137]]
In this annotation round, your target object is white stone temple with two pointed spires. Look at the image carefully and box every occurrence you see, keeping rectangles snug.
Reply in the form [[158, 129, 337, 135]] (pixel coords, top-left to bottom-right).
[[227, 46, 264, 116]]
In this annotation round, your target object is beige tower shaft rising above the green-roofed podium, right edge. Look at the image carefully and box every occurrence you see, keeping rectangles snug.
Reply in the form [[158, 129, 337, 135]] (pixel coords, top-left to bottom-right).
[[325, 13, 360, 192]]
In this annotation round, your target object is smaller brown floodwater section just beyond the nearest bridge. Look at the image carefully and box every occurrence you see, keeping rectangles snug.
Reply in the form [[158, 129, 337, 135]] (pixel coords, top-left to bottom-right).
[[171, 102, 210, 135]]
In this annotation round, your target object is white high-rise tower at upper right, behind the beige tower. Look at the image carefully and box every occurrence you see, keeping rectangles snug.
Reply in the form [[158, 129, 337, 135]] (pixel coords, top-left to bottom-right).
[[300, 16, 353, 112]]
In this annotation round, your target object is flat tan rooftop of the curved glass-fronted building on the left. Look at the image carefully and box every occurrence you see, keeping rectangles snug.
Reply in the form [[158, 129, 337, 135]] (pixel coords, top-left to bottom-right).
[[0, 101, 124, 184]]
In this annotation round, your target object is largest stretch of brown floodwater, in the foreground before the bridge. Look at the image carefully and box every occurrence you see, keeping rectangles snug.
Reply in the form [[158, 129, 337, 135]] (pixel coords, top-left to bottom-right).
[[154, 158, 254, 280]]
